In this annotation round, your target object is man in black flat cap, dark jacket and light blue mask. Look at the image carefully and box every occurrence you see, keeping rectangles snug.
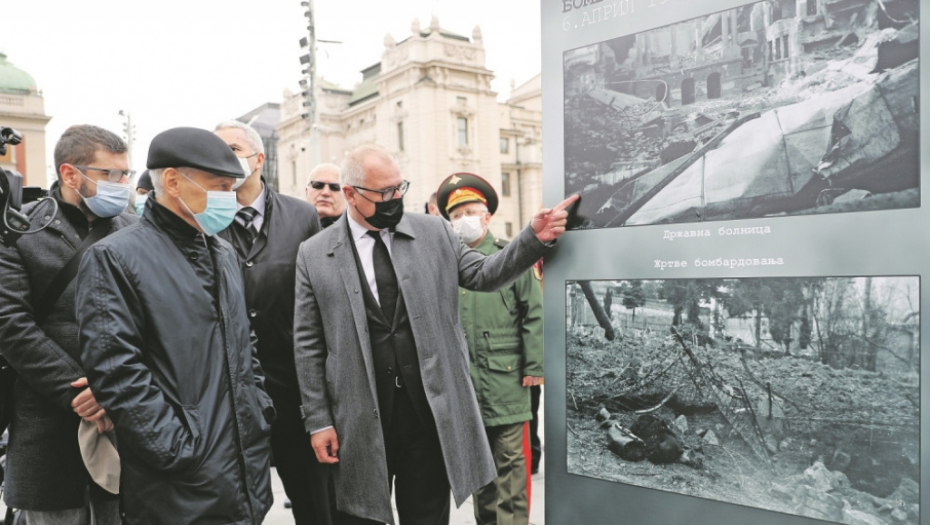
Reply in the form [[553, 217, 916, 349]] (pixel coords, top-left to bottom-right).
[[76, 128, 275, 525]]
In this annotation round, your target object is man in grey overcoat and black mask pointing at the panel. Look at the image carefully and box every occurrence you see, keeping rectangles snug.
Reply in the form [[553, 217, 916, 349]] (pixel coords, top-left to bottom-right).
[[294, 146, 577, 525]]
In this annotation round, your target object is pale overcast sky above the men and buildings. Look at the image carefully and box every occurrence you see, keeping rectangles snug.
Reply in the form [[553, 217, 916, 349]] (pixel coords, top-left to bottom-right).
[[0, 0, 540, 178]]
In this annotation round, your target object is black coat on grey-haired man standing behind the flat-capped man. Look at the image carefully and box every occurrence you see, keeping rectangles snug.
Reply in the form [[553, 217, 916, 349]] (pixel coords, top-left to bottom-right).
[[220, 186, 320, 418]]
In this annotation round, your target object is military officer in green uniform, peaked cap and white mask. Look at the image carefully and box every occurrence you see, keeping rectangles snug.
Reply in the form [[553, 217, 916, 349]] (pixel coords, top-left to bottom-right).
[[437, 173, 543, 525]]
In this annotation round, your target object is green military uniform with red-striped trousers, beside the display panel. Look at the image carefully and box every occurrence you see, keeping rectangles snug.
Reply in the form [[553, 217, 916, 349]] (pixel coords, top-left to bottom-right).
[[459, 233, 543, 525]]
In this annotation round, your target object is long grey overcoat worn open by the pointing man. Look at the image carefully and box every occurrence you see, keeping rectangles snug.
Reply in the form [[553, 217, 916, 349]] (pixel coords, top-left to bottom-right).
[[294, 214, 547, 523]]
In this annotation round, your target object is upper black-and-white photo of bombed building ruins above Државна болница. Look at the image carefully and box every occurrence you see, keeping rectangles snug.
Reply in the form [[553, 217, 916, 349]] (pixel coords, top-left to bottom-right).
[[563, 0, 920, 229]]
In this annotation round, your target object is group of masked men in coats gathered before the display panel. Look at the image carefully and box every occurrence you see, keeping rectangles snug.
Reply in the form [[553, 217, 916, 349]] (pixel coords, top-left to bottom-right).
[[0, 121, 575, 525]]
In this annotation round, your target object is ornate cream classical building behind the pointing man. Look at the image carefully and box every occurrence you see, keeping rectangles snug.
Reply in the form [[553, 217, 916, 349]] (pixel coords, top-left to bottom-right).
[[277, 17, 542, 238]]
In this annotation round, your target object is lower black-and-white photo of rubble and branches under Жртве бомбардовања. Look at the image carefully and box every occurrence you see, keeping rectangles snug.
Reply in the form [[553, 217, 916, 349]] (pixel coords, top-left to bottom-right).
[[565, 276, 921, 525]]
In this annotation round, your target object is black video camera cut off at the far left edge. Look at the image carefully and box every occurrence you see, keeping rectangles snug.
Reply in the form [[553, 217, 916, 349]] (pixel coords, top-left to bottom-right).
[[0, 127, 58, 246]]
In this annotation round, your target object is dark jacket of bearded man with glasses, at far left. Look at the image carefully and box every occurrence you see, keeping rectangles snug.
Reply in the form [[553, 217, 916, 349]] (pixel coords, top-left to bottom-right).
[[0, 186, 139, 511]]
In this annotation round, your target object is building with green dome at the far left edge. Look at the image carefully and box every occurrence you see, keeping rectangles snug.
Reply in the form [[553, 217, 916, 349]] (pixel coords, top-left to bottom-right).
[[0, 53, 51, 186]]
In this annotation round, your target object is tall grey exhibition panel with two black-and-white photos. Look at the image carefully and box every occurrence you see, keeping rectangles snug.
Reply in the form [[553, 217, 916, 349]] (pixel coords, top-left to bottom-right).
[[541, 0, 930, 525]]
